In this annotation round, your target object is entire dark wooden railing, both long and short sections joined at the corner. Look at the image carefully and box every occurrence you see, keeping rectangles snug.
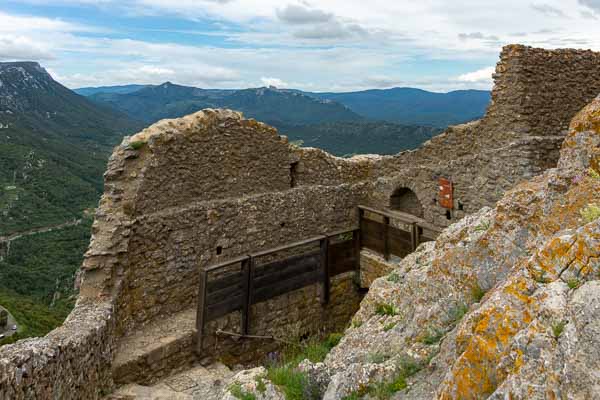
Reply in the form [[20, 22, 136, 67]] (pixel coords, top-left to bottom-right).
[[196, 206, 440, 354]]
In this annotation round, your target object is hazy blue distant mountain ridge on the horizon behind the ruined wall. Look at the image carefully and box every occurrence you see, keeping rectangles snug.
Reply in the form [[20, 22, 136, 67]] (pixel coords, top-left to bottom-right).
[[76, 82, 491, 128]]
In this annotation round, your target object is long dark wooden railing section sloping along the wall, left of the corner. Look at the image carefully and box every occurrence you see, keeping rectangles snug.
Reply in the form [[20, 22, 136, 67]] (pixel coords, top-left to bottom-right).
[[196, 228, 360, 354]]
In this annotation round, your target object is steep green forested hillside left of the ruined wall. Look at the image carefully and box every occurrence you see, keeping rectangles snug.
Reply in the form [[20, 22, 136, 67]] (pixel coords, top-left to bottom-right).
[[0, 62, 143, 340]]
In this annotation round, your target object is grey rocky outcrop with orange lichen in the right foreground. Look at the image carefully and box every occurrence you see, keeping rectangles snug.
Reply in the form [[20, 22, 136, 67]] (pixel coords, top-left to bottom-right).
[[225, 97, 600, 399]]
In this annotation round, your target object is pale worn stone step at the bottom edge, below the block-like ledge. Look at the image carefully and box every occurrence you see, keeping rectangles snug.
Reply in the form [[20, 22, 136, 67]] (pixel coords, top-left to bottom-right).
[[106, 363, 234, 400]]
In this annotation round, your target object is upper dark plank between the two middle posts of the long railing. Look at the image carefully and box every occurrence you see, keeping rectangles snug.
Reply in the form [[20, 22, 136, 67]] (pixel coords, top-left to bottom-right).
[[253, 252, 320, 289]]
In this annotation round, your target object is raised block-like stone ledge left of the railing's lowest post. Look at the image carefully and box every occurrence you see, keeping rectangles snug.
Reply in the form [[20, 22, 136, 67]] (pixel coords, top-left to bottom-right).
[[113, 308, 196, 385]]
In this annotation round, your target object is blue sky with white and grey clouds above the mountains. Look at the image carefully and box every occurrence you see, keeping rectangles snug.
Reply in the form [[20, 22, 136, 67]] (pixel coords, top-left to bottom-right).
[[0, 0, 600, 92]]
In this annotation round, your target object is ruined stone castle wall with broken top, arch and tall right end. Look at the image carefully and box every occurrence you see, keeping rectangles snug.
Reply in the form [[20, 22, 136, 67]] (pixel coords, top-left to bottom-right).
[[0, 46, 600, 399]]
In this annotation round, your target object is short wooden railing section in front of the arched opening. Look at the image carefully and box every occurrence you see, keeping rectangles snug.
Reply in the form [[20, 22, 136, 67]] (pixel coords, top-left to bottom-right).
[[358, 206, 441, 260]]
